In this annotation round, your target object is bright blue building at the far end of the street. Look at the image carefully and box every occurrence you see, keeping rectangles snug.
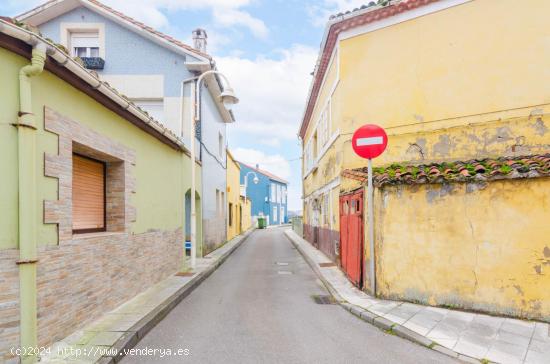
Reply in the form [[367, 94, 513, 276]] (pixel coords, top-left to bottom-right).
[[239, 162, 288, 225]]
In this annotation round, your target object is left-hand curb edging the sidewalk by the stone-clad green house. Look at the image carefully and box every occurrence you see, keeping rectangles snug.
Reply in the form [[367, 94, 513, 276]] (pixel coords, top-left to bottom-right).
[[100, 228, 255, 364]]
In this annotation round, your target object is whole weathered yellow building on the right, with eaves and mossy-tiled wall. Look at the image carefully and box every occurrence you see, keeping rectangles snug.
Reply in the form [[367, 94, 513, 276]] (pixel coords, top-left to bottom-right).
[[300, 0, 550, 321]]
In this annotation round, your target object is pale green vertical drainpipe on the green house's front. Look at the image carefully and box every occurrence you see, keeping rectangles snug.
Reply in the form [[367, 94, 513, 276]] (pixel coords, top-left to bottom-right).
[[16, 43, 46, 363]]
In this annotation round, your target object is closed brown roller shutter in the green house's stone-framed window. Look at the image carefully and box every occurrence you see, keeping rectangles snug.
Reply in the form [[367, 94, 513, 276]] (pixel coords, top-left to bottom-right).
[[73, 154, 105, 232]]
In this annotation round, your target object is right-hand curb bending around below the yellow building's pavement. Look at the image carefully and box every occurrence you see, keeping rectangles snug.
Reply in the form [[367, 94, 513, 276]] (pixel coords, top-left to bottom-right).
[[285, 230, 480, 363]]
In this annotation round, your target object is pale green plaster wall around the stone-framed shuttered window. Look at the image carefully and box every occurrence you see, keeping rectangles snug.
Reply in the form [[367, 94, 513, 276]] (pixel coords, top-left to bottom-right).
[[0, 48, 201, 249]]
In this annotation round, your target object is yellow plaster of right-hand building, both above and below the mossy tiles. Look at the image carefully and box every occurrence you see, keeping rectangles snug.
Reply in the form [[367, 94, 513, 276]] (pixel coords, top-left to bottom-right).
[[303, 0, 550, 319]]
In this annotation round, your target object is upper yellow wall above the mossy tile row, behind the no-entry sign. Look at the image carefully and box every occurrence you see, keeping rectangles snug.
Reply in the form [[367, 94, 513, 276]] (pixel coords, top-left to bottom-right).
[[339, 0, 550, 168]]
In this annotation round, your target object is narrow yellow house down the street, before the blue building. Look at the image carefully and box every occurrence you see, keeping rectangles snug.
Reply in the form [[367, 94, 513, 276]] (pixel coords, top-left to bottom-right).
[[226, 150, 252, 240]]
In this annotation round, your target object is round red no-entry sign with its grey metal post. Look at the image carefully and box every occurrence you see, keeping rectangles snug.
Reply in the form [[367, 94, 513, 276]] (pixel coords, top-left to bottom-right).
[[352, 124, 388, 296]]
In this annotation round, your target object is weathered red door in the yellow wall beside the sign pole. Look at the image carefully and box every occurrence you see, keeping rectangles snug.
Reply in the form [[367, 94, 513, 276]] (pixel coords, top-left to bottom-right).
[[340, 191, 363, 287]]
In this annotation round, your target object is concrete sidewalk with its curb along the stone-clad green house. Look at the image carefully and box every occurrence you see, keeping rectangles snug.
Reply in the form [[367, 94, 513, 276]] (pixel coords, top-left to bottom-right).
[[40, 230, 254, 364]]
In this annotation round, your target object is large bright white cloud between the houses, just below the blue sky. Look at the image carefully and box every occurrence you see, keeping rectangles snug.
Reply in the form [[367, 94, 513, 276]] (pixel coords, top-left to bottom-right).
[[216, 45, 317, 141]]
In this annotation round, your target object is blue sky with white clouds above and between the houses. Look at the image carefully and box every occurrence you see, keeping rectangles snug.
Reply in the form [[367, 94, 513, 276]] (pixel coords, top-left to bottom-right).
[[0, 0, 369, 211]]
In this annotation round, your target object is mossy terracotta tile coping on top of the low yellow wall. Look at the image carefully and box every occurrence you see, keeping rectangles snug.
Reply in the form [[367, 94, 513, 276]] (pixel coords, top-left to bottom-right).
[[342, 154, 550, 187]]
